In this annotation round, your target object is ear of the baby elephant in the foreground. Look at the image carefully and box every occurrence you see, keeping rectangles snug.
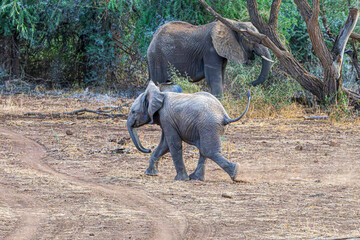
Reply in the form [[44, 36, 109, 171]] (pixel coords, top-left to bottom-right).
[[145, 81, 165, 122]]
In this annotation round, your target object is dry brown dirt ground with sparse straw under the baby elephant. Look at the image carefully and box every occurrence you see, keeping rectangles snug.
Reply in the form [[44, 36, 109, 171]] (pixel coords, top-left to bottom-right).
[[0, 96, 360, 239]]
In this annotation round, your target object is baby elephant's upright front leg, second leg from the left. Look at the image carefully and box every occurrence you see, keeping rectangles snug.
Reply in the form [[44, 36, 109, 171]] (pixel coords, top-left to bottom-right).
[[164, 128, 189, 180]]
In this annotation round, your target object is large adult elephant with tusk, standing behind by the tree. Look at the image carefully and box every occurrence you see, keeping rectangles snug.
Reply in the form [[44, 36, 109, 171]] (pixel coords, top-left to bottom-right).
[[147, 19, 271, 97]]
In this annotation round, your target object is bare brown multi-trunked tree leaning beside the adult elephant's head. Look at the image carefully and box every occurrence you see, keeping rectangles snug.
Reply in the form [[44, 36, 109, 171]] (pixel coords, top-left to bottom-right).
[[198, 0, 360, 102]]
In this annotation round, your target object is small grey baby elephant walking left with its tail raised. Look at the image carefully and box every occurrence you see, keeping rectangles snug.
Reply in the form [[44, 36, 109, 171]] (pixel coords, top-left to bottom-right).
[[127, 81, 250, 181]]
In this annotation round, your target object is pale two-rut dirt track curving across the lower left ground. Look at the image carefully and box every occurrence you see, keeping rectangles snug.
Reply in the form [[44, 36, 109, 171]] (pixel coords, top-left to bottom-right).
[[0, 128, 193, 240]]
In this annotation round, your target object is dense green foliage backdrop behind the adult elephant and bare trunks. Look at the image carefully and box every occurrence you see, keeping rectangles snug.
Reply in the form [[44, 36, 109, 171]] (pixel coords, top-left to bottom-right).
[[0, 0, 358, 99]]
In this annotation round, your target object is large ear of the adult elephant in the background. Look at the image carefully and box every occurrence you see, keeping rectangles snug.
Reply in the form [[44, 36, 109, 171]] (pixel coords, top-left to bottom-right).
[[211, 19, 246, 63]]
